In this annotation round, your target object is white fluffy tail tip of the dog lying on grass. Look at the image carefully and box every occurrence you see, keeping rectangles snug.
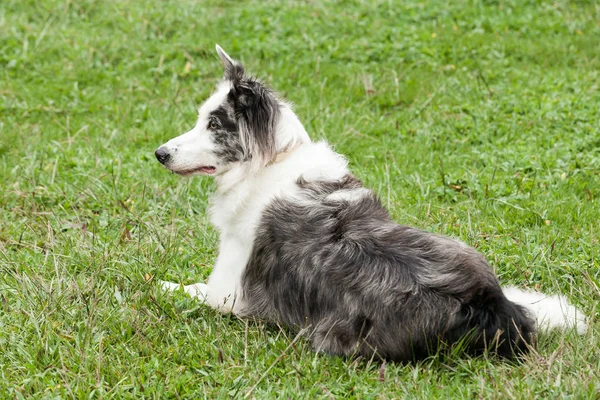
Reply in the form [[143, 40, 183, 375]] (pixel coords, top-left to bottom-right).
[[502, 287, 587, 335]]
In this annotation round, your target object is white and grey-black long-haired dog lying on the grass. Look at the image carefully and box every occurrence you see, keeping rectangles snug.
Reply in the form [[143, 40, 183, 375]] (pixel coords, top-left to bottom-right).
[[155, 46, 586, 361]]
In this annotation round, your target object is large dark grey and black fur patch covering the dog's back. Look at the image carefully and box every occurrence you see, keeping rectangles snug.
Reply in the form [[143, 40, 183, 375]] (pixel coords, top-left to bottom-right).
[[242, 176, 534, 361]]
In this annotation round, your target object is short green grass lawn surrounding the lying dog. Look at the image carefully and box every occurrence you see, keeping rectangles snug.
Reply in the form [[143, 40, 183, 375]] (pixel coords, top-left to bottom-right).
[[0, 0, 600, 399]]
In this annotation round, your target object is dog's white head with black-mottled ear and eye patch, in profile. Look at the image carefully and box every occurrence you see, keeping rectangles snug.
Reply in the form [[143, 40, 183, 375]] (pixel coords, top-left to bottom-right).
[[155, 45, 281, 175]]
